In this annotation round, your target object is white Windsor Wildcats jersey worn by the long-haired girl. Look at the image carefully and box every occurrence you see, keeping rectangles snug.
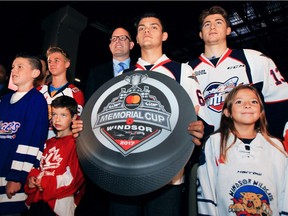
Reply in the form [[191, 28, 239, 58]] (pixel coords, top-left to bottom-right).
[[197, 133, 288, 216]]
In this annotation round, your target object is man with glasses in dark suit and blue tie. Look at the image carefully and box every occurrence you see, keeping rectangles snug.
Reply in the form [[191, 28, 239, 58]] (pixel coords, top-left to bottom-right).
[[85, 27, 134, 101]]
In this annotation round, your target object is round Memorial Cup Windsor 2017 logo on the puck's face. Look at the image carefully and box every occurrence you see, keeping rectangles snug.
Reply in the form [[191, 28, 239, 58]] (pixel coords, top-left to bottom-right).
[[91, 72, 179, 156]]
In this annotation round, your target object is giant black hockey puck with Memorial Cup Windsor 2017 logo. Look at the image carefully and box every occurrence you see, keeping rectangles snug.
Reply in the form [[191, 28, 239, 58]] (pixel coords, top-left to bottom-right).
[[77, 71, 196, 196]]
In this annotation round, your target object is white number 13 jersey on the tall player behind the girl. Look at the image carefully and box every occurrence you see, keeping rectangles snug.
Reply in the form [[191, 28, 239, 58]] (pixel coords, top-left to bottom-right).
[[188, 49, 288, 139]]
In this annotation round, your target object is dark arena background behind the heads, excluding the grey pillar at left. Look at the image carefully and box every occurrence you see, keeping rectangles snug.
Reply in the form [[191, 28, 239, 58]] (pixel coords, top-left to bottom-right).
[[0, 1, 288, 90]]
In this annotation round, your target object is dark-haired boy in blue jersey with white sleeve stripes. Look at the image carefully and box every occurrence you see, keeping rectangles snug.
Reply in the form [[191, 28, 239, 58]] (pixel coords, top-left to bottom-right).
[[0, 54, 48, 216]]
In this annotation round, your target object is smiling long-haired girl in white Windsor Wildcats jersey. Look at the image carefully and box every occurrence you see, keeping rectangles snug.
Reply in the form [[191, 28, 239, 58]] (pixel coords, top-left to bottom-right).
[[197, 85, 288, 216]]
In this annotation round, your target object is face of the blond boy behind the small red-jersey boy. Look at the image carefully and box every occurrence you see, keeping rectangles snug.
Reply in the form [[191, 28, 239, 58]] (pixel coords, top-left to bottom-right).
[[47, 52, 70, 75]]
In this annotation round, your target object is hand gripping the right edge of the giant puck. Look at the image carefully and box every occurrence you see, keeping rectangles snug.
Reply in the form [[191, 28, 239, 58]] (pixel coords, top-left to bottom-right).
[[188, 105, 204, 146]]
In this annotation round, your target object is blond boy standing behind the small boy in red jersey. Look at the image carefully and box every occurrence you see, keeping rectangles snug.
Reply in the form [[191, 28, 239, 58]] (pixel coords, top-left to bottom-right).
[[38, 47, 84, 138]]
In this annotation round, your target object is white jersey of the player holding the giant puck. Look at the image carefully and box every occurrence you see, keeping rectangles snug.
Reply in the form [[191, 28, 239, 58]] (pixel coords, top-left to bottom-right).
[[126, 54, 212, 125]]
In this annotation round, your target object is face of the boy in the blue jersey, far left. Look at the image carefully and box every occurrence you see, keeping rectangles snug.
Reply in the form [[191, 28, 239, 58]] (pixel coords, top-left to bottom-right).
[[11, 57, 40, 88]]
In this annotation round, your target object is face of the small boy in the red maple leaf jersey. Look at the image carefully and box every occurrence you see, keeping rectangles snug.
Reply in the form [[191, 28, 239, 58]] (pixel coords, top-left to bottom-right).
[[51, 107, 73, 135]]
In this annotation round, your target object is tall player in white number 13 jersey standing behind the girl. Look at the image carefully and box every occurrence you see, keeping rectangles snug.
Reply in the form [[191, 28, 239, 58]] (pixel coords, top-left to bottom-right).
[[189, 6, 288, 139]]
